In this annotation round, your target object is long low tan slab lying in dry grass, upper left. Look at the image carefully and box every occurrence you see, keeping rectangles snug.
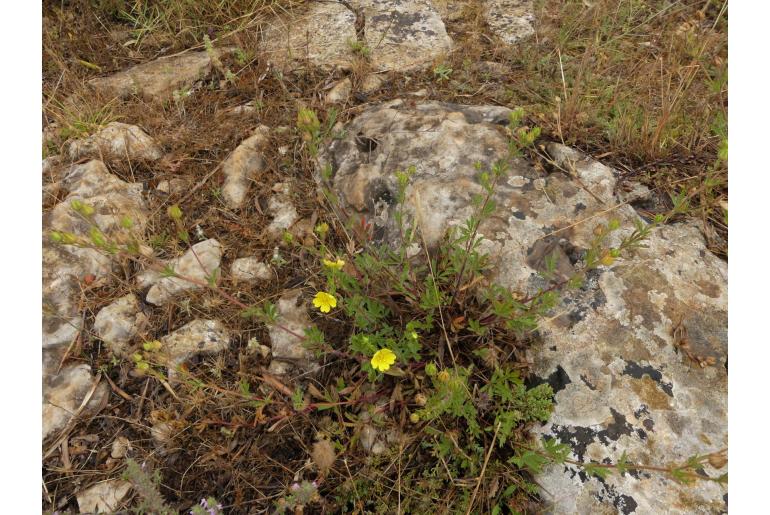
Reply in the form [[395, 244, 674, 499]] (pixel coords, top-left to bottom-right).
[[89, 50, 228, 100]]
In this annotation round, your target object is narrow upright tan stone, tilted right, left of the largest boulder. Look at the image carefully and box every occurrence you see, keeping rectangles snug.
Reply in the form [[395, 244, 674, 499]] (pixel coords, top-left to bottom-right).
[[222, 125, 270, 209]]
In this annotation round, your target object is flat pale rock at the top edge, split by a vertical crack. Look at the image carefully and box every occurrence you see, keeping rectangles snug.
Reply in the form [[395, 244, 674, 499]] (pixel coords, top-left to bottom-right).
[[264, 0, 452, 71]]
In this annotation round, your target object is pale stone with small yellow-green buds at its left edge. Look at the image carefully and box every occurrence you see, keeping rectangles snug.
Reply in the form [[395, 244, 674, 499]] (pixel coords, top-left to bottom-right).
[[160, 319, 230, 378]]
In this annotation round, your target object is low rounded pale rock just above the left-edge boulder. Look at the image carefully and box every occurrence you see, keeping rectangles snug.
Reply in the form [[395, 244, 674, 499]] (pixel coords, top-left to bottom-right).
[[69, 122, 163, 161]]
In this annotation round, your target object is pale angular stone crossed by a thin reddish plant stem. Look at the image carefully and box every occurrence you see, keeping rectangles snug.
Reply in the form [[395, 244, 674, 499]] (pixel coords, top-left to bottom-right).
[[137, 239, 222, 306]]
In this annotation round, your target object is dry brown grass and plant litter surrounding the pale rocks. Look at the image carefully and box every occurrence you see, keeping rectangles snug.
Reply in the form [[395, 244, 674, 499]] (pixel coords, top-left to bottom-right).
[[43, 0, 727, 513]]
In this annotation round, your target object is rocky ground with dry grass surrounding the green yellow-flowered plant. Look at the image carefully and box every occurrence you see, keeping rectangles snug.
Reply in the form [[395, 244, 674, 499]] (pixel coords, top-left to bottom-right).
[[42, 0, 727, 514]]
